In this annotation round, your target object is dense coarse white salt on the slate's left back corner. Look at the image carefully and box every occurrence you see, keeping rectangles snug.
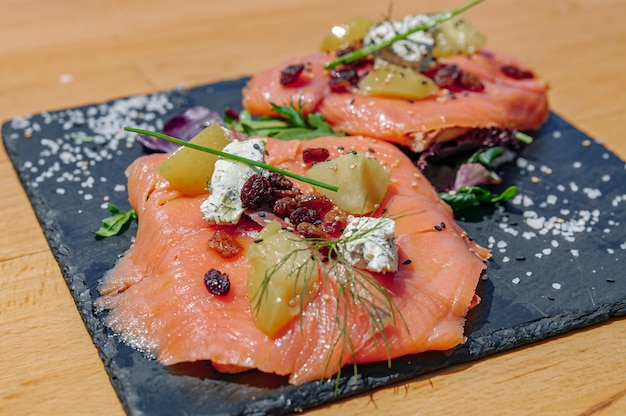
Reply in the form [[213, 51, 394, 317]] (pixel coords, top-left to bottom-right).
[[10, 91, 175, 205]]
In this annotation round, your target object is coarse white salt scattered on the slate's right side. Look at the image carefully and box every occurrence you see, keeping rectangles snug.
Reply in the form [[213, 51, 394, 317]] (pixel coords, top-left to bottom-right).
[[472, 135, 626, 301]]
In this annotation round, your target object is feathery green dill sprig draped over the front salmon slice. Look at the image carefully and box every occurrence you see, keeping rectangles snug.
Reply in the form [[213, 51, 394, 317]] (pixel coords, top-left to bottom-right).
[[251, 211, 408, 381]]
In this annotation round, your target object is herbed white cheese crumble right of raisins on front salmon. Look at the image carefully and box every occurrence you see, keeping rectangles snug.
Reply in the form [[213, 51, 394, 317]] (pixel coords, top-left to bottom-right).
[[339, 215, 398, 273]]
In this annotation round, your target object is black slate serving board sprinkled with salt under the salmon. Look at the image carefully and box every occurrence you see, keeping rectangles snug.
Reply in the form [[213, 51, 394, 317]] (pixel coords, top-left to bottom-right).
[[2, 79, 626, 415]]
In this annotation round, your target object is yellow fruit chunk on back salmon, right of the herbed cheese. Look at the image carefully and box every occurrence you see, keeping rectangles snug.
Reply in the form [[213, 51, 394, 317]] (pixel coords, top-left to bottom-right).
[[433, 16, 487, 58]]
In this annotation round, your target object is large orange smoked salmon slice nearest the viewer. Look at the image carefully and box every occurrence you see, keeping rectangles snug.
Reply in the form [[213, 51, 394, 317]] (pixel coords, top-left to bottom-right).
[[95, 136, 490, 384]]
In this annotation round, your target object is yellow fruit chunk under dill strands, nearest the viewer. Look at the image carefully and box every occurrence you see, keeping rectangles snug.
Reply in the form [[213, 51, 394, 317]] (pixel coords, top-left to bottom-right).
[[246, 221, 319, 337]]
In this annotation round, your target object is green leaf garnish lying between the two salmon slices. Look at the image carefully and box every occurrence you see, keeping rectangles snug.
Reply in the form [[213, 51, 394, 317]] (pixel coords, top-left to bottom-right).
[[224, 102, 345, 140]]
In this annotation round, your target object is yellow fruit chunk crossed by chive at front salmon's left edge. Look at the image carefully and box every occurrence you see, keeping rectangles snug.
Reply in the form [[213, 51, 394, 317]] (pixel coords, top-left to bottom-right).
[[157, 124, 231, 196]]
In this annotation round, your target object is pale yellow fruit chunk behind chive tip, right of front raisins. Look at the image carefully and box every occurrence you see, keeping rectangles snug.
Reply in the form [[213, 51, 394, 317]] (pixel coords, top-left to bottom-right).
[[306, 152, 391, 215]]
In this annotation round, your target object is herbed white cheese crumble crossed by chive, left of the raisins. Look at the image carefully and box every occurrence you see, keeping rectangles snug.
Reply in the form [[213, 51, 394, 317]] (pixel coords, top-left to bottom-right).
[[200, 139, 267, 224]]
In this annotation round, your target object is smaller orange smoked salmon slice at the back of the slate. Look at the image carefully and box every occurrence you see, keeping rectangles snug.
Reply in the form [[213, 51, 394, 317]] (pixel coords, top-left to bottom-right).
[[243, 48, 549, 152]]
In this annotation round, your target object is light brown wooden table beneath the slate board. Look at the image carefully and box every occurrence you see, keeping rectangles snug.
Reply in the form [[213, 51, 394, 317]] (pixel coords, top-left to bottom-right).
[[0, 0, 626, 415]]
